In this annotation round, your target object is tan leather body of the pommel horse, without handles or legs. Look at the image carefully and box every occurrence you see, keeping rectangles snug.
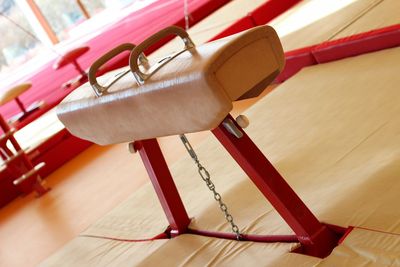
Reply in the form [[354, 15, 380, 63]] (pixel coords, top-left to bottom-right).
[[57, 26, 284, 145]]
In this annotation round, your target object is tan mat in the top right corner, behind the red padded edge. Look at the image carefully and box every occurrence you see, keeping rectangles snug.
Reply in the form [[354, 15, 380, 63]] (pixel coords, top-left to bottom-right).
[[268, 0, 400, 51]]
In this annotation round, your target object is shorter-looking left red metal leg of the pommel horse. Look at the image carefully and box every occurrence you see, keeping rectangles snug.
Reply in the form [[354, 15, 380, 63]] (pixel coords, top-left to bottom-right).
[[134, 139, 190, 236]]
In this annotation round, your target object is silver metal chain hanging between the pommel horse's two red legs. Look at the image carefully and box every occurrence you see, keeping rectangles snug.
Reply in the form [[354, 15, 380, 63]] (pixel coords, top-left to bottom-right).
[[179, 134, 241, 240]]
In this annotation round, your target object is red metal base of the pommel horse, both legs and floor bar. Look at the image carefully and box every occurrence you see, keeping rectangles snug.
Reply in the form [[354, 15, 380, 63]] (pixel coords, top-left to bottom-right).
[[134, 115, 344, 257]]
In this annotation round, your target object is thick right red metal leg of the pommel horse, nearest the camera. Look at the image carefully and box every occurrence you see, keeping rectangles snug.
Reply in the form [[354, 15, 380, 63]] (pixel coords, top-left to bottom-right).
[[212, 115, 338, 257]]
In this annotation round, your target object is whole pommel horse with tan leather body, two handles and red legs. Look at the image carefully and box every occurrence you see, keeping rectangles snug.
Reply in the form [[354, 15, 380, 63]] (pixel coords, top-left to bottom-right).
[[57, 26, 345, 258]]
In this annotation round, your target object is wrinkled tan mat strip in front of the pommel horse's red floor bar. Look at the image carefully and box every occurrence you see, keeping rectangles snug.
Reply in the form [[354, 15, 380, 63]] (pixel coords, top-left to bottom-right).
[[40, 228, 400, 267]]
